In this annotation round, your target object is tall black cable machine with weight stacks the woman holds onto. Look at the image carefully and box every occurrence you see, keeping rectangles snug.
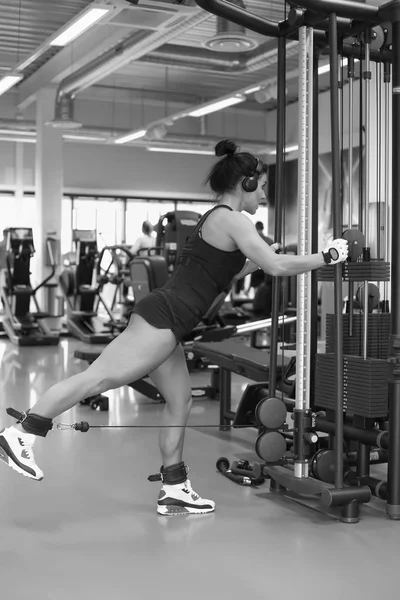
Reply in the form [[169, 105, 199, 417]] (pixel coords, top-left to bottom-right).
[[196, 0, 400, 523]]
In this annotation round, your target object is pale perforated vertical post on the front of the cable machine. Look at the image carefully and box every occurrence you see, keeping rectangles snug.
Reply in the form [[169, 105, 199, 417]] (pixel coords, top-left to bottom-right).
[[294, 27, 313, 478]]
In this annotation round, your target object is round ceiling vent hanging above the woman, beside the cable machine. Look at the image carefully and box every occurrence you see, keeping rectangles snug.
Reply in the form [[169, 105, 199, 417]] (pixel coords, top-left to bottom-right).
[[203, 0, 257, 52]]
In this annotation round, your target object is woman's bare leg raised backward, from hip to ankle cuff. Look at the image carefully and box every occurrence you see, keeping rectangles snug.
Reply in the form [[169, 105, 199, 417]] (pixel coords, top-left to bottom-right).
[[19, 314, 176, 419]]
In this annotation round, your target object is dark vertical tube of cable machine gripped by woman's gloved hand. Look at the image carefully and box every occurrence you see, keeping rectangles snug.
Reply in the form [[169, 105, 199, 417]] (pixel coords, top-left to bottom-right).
[[329, 13, 343, 489]]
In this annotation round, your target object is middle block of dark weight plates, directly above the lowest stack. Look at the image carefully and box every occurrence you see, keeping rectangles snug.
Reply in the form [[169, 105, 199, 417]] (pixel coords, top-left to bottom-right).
[[326, 313, 392, 360]]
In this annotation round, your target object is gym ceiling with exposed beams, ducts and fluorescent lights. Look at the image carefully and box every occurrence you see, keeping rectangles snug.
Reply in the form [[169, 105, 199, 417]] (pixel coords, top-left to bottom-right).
[[0, 0, 350, 150]]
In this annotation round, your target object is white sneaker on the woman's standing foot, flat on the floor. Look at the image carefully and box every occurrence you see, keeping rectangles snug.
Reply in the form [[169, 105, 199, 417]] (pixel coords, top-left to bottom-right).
[[157, 479, 215, 516]]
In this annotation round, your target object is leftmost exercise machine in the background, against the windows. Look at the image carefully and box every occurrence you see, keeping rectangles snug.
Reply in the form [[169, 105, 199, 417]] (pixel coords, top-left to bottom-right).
[[0, 227, 60, 346]]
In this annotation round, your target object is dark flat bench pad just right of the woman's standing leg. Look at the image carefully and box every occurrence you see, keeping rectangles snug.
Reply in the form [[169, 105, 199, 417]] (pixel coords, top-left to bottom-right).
[[192, 338, 290, 381]]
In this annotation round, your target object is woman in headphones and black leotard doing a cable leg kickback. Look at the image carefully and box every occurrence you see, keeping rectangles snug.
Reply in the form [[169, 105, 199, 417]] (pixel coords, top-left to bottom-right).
[[0, 140, 347, 515]]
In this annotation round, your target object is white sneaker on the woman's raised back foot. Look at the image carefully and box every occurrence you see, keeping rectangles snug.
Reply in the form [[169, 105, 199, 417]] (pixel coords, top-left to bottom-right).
[[0, 427, 43, 481]]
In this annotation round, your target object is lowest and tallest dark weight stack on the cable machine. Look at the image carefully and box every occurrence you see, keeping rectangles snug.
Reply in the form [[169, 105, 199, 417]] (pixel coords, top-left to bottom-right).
[[315, 354, 389, 419]]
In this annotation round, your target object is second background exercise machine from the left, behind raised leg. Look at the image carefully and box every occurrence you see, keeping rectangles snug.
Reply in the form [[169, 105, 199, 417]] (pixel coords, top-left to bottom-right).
[[59, 229, 120, 344]]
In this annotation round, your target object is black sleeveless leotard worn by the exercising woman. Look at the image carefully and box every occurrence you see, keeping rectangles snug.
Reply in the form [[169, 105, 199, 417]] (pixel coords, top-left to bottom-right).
[[133, 204, 246, 342]]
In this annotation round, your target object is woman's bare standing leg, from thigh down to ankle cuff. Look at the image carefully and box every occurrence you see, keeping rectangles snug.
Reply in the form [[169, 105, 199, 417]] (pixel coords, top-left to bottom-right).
[[150, 345, 192, 467]]
